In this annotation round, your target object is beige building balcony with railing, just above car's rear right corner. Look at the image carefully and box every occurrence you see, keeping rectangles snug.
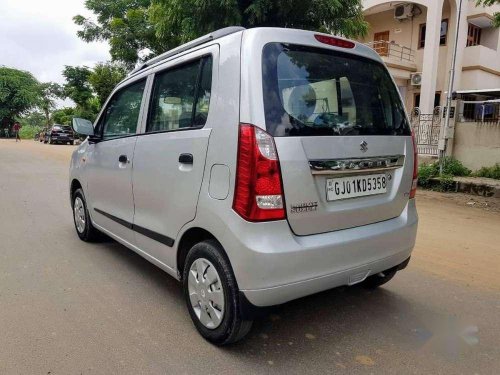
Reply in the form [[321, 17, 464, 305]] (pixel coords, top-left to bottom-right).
[[365, 40, 417, 72]]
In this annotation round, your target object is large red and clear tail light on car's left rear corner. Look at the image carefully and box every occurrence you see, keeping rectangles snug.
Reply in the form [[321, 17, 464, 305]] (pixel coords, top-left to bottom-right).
[[233, 124, 286, 221]]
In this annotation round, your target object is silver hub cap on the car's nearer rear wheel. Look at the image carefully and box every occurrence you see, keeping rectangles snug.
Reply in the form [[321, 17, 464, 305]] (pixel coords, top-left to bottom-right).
[[188, 258, 225, 329]]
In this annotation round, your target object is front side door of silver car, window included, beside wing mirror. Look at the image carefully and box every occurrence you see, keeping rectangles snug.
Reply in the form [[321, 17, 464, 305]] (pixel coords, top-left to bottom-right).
[[87, 79, 146, 244]]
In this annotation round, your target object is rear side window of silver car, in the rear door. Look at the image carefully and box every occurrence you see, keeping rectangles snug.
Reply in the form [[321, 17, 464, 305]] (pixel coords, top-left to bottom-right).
[[146, 57, 212, 133]]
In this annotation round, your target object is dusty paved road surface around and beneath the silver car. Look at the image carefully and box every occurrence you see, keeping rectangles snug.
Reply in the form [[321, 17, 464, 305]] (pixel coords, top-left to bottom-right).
[[0, 140, 500, 374]]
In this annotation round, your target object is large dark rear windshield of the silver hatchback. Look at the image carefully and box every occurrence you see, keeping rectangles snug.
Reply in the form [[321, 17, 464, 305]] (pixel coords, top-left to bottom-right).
[[262, 43, 411, 137]]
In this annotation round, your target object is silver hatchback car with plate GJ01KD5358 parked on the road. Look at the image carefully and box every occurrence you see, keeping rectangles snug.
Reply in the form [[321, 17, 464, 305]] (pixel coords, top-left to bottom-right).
[[70, 27, 418, 345]]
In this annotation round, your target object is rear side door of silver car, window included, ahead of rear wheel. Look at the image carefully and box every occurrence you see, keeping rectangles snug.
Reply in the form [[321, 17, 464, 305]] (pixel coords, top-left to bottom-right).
[[132, 46, 218, 268]]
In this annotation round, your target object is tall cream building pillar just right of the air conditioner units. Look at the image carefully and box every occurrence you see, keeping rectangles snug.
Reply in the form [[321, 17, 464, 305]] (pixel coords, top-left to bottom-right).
[[420, 0, 443, 113]]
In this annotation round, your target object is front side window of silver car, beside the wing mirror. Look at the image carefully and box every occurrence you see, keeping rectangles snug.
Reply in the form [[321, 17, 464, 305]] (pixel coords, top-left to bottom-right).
[[102, 80, 146, 139]]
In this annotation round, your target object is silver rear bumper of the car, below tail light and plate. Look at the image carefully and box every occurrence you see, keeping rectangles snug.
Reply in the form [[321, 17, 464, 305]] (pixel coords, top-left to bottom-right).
[[223, 199, 418, 306]]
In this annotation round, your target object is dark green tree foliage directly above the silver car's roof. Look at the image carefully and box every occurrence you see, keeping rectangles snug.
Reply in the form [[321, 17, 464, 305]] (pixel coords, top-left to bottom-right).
[[150, 0, 367, 47]]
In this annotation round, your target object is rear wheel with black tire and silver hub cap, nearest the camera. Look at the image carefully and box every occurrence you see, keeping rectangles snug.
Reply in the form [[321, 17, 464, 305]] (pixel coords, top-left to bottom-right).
[[182, 240, 252, 346]]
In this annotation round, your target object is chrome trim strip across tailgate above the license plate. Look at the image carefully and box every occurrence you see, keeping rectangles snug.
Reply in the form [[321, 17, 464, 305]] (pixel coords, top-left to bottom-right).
[[309, 155, 405, 175]]
